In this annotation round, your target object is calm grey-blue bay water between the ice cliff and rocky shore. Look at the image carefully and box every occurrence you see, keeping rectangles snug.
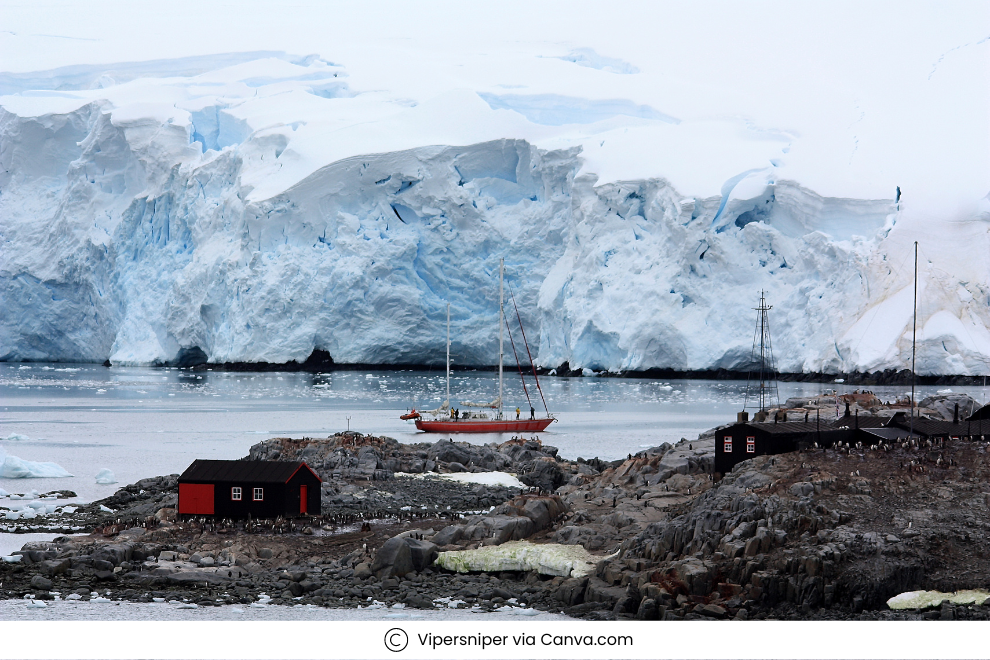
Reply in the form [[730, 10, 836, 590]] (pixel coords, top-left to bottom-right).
[[0, 363, 984, 499]]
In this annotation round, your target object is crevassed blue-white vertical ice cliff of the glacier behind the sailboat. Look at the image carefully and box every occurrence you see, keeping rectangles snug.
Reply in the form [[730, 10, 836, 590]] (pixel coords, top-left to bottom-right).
[[0, 56, 990, 374]]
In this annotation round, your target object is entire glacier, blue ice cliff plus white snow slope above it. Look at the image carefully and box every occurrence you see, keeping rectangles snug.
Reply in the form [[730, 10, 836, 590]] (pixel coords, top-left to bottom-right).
[[0, 3, 990, 373]]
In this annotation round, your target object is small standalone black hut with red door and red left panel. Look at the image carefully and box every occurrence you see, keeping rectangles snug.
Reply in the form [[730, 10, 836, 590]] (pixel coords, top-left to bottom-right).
[[178, 460, 323, 518]]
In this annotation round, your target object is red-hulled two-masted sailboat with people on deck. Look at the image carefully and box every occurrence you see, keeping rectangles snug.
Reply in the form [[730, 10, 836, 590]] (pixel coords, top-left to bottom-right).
[[402, 259, 557, 433]]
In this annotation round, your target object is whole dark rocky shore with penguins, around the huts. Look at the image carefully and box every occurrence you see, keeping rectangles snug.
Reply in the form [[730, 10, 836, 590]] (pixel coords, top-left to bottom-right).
[[0, 433, 990, 620]]
